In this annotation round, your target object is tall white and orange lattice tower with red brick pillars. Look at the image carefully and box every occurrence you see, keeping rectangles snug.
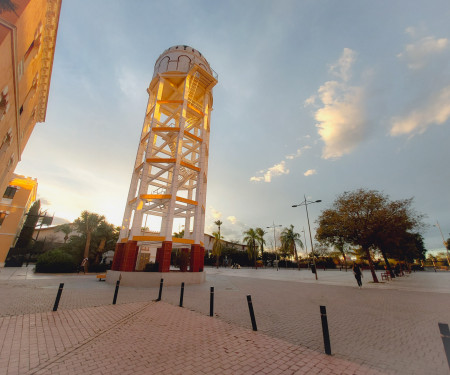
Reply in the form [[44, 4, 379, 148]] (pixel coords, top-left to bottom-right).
[[112, 45, 218, 272]]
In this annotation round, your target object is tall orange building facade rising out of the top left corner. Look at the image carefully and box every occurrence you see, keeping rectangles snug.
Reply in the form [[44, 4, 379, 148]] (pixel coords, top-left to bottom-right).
[[0, 0, 61, 192]]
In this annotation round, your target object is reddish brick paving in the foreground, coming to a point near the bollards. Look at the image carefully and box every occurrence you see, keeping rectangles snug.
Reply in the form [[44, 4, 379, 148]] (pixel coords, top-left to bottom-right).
[[0, 302, 381, 375]]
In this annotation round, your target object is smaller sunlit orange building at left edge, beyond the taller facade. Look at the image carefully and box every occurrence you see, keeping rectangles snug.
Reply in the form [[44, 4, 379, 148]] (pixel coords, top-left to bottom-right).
[[0, 174, 37, 267]]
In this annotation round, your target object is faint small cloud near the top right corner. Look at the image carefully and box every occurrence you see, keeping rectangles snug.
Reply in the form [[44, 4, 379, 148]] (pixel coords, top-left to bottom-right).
[[397, 34, 449, 69]]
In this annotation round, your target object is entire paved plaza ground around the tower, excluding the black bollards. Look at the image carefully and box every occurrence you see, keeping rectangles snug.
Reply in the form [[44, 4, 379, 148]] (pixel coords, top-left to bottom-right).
[[0, 267, 450, 374]]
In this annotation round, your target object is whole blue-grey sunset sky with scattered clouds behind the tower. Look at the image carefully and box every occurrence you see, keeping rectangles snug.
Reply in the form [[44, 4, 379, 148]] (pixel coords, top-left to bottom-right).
[[16, 0, 450, 251]]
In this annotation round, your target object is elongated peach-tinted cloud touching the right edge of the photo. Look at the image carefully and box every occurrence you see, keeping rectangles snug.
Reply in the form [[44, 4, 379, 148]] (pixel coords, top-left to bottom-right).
[[390, 86, 450, 136]]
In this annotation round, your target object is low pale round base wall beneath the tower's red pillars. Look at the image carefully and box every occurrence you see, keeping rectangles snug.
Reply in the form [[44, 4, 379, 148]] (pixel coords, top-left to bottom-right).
[[106, 270, 206, 287]]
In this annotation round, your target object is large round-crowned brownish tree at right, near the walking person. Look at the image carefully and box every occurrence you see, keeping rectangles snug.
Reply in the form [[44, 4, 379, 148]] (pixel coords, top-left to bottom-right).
[[316, 189, 423, 282]]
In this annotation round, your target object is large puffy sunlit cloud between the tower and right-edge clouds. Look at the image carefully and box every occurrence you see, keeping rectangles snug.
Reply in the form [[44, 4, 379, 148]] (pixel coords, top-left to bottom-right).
[[305, 48, 366, 159]]
